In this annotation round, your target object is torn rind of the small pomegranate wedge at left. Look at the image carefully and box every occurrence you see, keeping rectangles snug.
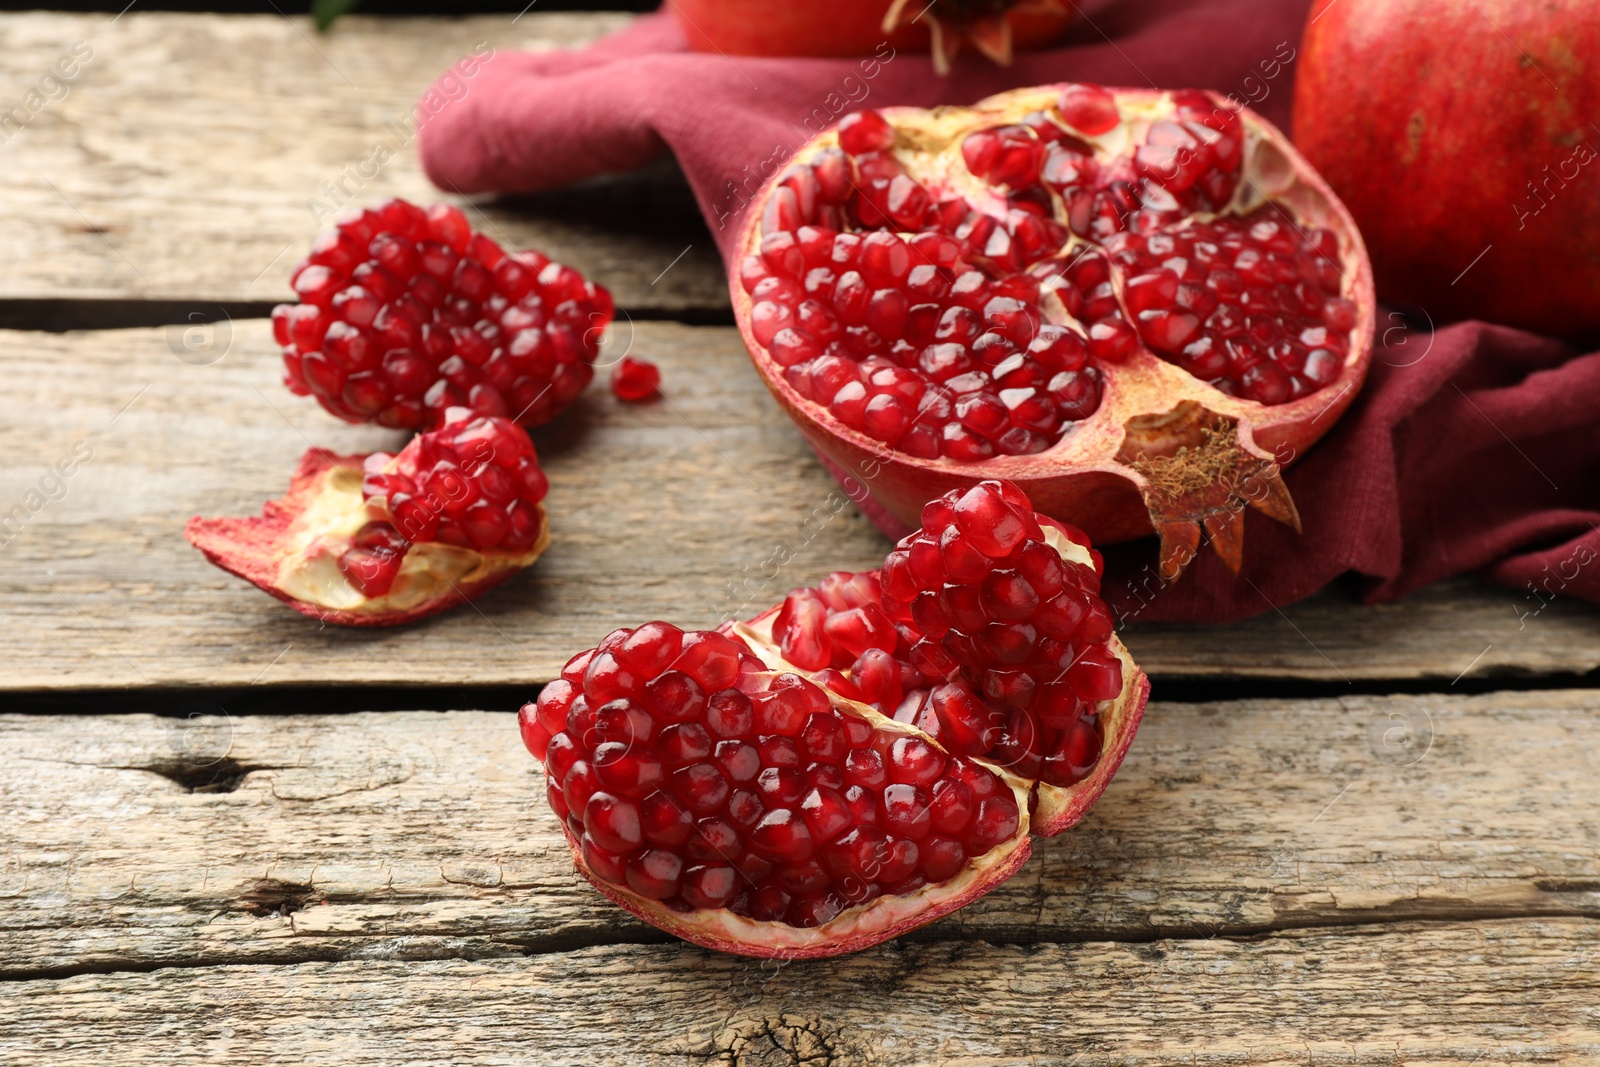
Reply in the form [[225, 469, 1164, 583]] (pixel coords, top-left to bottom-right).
[[184, 448, 550, 627]]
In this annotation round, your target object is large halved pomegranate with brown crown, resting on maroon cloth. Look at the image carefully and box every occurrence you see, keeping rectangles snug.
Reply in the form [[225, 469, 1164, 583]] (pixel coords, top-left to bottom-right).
[[731, 85, 1374, 579]]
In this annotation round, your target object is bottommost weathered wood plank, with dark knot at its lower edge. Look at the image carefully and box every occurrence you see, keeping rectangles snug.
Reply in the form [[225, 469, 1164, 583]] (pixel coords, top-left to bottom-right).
[[0, 920, 1600, 1067]]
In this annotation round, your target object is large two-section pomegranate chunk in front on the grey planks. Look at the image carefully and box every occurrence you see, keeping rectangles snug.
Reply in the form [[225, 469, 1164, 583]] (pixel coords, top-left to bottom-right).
[[518, 482, 1149, 958]]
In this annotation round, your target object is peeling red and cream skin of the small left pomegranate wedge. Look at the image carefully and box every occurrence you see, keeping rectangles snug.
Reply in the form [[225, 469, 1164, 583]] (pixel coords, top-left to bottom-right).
[[184, 448, 549, 625]]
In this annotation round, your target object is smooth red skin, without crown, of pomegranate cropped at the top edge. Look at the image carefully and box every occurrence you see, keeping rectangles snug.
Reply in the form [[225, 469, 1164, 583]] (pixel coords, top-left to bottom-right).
[[667, 0, 1074, 58]]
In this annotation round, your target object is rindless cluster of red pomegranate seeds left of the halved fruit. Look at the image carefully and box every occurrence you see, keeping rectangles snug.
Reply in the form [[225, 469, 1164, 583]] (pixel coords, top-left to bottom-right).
[[272, 200, 614, 430]]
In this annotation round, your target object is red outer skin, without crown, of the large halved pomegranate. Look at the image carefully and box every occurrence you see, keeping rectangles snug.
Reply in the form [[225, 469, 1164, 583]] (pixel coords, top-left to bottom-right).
[[728, 86, 1374, 550]]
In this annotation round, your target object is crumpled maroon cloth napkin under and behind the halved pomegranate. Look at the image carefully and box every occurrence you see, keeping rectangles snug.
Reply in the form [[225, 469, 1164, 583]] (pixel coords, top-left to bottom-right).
[[419, 0, 1600, 622]]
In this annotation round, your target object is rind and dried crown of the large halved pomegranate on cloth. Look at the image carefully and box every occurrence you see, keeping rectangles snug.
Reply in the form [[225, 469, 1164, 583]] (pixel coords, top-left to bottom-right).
[[728, 83, 1376, 566]]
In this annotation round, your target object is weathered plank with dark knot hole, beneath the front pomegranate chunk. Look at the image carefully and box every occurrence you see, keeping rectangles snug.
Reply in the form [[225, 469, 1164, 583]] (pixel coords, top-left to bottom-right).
[[0, 691, 1600, 977]]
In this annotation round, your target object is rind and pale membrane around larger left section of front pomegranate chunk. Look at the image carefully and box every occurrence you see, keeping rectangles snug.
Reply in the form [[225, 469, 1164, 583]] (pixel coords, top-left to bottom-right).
[[562, 667, 1034, 960]]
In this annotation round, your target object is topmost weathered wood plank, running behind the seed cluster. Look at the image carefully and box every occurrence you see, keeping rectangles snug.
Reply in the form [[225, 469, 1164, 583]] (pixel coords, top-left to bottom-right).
[[0, 5, 726, 322]]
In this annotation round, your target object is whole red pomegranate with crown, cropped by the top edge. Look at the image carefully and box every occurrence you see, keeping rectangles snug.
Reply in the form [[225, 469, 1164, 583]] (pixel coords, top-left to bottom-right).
[[667, 0, 1075, 74]]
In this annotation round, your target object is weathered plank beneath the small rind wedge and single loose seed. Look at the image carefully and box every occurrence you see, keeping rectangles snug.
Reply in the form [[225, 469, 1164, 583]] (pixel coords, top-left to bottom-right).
[[0, 320, 1600, 691]]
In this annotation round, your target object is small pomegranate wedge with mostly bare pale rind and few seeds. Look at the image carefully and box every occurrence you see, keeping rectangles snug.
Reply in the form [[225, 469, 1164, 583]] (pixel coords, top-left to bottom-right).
[[184, 408, 550, 625]]
